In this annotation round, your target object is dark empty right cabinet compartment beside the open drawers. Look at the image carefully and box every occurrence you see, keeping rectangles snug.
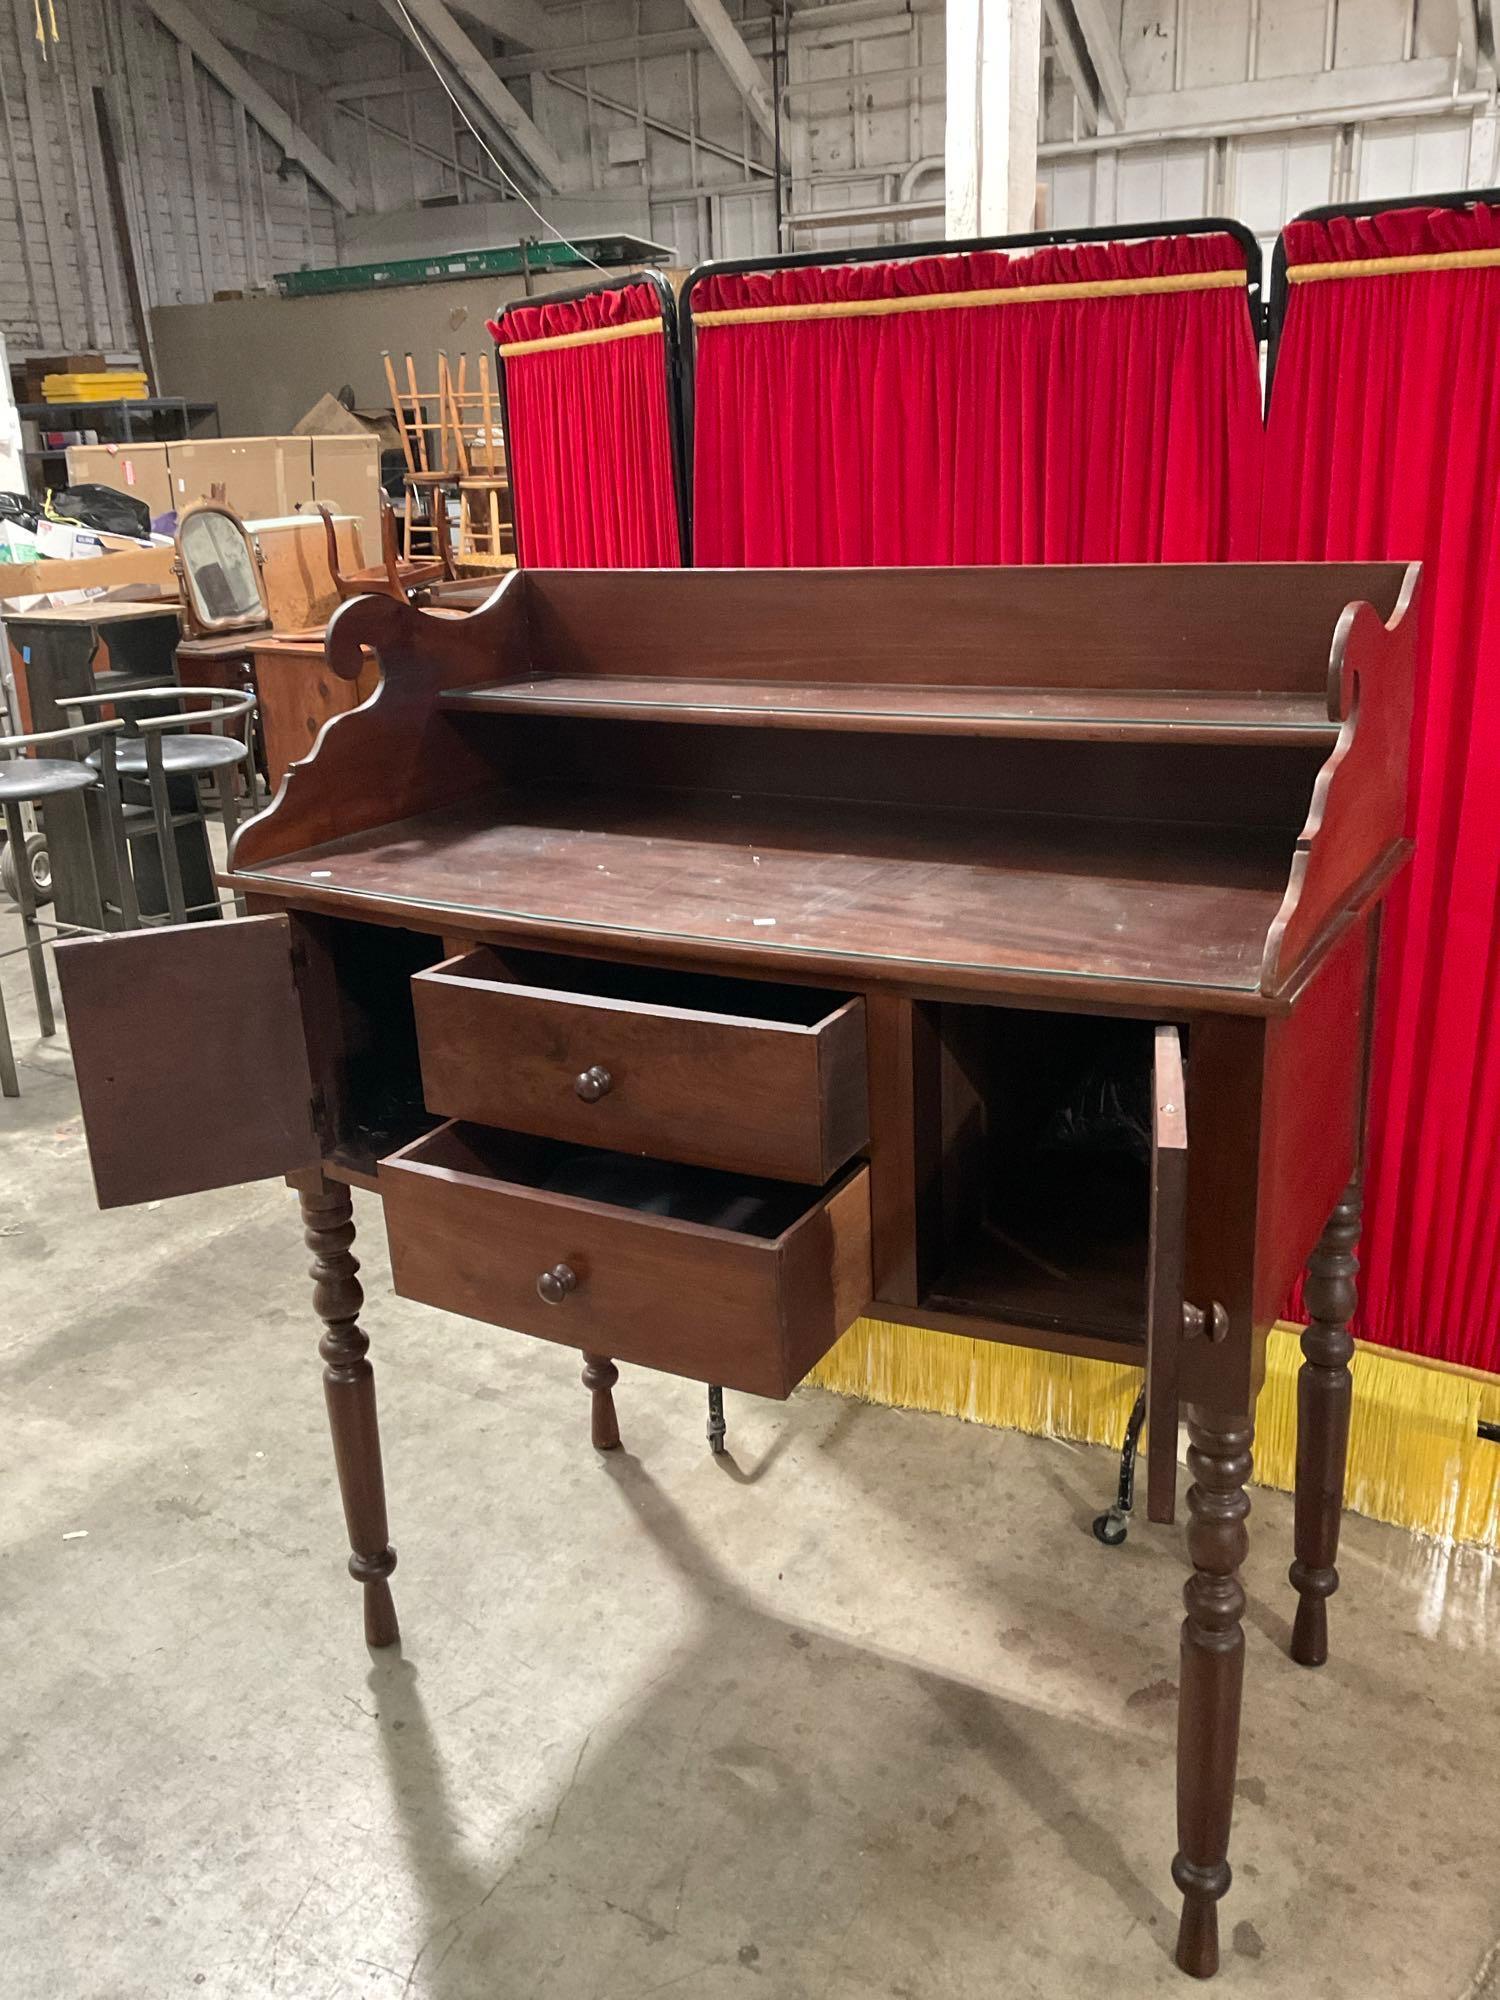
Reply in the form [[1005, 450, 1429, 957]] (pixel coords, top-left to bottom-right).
[[924, 1004, 1152, 1344]]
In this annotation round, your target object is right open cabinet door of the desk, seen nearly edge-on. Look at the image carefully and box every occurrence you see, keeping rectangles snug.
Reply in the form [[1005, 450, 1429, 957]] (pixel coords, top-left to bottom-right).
[[1146, 1028, 1188, 1520]]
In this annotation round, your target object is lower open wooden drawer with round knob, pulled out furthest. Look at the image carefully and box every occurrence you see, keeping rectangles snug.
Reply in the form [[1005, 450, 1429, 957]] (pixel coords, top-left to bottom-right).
[[380, 1124, 870, 1396]]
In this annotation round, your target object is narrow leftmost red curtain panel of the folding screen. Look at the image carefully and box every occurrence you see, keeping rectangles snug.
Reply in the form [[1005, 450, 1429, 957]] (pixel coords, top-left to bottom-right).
[[490, 284, 682, 570]]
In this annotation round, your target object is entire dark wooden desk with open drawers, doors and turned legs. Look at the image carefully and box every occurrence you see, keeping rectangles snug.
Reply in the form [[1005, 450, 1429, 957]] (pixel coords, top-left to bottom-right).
[[58, 564, 1416, 1974]]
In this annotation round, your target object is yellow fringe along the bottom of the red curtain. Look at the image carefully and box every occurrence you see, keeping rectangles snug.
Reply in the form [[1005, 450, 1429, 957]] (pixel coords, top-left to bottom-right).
[[810, 1320, 1500, 1550]]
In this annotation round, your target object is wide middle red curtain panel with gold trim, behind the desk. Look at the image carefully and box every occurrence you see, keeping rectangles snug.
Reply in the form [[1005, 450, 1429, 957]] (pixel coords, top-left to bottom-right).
[[692, 234, 1262, 566]]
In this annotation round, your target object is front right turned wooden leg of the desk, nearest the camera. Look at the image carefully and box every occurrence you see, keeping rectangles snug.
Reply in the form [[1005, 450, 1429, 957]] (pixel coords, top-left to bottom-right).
[[1172, 1406, 1254, 1980]]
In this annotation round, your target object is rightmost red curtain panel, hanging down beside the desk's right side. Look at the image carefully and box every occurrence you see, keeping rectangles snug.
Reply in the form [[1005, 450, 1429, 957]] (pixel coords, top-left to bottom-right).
[[1262, 208, 1500, 1370]]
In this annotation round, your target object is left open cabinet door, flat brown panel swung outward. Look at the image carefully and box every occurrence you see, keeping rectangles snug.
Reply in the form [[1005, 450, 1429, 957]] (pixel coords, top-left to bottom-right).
[[56, 916, 322, 1208]]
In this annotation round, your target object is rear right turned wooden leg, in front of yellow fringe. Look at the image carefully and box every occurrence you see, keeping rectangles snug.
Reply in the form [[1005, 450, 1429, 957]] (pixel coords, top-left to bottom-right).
[[1288, 1182, 1360, 1666]]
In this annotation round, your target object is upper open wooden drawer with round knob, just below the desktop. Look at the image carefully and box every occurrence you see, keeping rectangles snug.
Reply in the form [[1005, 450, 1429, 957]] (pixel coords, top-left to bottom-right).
[[412, 946, 868, 1186]]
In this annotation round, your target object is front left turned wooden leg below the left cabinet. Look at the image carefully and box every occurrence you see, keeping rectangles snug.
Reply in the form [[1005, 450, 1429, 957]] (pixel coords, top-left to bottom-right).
[[302, 1180, 400, 1646]]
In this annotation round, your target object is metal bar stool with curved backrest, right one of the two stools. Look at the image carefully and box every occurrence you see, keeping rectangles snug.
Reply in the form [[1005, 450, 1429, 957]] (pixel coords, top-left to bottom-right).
[[64, 686, 256, 930]]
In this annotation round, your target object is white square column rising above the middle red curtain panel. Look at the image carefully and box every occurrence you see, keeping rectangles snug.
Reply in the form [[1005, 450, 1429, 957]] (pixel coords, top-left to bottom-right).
[[944, 0, 1042, 236]]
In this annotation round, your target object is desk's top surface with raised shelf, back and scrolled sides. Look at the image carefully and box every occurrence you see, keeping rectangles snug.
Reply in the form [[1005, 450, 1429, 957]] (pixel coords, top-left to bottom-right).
[[223, 564, 1416, 1008]]
